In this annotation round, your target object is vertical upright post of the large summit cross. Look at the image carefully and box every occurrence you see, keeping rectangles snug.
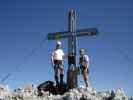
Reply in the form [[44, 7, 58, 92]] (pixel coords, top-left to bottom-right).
[[67, 10, 78, 88]]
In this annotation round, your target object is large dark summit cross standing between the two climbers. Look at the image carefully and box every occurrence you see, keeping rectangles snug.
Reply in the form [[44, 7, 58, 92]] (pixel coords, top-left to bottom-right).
[[47, 10, 98, 88]]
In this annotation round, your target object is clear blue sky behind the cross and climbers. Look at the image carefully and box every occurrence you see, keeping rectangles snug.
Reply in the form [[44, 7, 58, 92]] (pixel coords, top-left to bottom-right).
[[0, 0, 133, 96]]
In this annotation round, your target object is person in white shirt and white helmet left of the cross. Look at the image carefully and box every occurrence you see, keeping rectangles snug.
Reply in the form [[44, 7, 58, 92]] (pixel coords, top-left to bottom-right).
[[51, 41, 64, 86]]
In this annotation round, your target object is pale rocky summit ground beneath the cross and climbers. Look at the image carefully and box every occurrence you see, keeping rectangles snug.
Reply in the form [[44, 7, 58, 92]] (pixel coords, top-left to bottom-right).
[[0, 85, 133, 100]]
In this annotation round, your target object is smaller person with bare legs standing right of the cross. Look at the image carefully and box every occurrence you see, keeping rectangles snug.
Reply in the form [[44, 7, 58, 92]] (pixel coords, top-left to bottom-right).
[[79, 48, 89, 87]]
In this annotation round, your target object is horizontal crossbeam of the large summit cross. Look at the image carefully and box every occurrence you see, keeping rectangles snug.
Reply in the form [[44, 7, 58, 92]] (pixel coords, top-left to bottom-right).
[[47, 28, 98, 40]]
